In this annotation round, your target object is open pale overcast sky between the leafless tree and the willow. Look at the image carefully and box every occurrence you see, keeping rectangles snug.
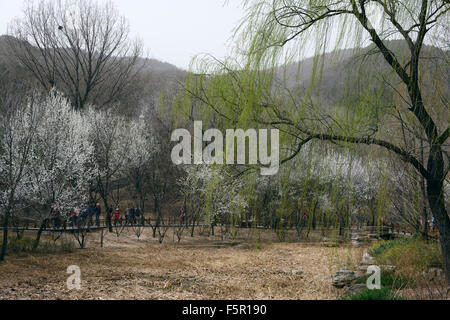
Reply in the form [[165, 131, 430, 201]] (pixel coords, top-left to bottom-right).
[[0, 0, 244, 69]]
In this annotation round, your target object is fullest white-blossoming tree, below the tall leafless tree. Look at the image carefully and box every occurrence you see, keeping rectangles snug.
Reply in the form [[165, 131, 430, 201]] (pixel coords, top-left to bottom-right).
[[28, 91, 95, 247]]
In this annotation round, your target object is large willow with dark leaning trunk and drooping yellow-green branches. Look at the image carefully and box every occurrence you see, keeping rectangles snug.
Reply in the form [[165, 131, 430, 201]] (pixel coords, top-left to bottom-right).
[[185, 0, 450, 282]]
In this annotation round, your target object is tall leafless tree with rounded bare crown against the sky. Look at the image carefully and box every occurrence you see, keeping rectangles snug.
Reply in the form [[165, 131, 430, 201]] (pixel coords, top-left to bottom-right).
[[7, 0, 144, 109]]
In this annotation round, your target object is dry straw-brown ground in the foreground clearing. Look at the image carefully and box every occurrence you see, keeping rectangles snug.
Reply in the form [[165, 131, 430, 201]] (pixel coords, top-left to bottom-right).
[[0, 230, 363, 300]]
